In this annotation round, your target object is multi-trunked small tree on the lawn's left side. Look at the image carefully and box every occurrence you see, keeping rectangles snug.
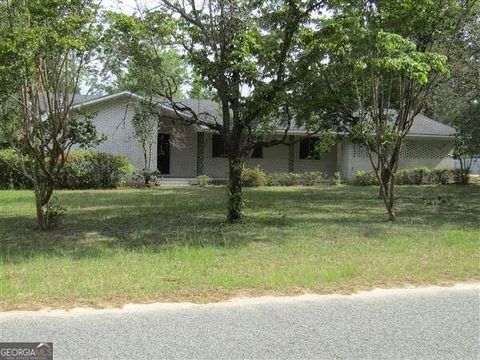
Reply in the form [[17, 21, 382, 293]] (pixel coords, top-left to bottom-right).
[[0, 0, 101, 230]]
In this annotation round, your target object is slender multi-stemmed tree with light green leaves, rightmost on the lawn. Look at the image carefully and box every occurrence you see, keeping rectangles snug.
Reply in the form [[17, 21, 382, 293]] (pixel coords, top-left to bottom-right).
[[299, 0, 470, 221]]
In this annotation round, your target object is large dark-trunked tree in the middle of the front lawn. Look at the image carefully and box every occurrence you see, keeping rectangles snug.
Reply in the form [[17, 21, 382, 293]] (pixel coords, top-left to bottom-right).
[[131, 0, 321, 222]]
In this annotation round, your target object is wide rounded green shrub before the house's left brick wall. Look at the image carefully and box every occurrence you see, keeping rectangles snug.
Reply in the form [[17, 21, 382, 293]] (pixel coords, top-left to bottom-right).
[[59, 151, 134, 189]]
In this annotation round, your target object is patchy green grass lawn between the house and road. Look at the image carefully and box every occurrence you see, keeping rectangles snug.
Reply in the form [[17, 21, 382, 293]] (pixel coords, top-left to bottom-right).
[[0, 185, 480, 310]]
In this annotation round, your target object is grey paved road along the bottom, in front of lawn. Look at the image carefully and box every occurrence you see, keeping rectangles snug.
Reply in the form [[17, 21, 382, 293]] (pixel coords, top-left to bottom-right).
[[0, 285, 480, 359]]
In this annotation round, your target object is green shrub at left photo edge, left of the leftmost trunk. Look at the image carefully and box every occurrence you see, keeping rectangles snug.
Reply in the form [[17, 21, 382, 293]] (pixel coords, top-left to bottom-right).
[[0, 149, 32, 189]]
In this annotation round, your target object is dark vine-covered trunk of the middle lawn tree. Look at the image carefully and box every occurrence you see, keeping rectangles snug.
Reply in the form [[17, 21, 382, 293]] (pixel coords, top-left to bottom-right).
[[227, 158, 244, 223]]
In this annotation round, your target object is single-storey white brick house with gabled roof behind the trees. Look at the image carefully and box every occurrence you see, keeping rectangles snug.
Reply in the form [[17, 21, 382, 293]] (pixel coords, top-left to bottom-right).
[[70, 91, 454, 179]]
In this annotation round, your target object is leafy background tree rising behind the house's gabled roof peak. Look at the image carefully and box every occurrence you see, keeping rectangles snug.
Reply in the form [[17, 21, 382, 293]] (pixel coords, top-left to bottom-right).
[[98, 11, 187, 96]]
